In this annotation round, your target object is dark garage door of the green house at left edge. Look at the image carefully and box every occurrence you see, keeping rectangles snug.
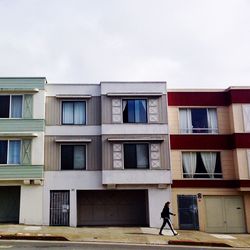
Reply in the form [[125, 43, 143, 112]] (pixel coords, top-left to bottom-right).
[[0, 186, 20, 223]]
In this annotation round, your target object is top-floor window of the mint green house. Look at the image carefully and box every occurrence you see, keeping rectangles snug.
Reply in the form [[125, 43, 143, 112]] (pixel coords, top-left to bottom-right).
[[0, 95, 23, 118]]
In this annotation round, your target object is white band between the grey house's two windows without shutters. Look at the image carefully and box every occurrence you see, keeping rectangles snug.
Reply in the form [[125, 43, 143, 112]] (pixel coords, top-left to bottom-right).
[[45, 125, 101, 136]]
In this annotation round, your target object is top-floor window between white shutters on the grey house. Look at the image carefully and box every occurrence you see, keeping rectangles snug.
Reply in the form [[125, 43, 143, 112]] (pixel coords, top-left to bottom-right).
[[122, 99, 147, 123]]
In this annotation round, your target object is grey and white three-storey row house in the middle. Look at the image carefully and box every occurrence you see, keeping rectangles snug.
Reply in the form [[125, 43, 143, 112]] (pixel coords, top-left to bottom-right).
[[43, 82, 171, 227]]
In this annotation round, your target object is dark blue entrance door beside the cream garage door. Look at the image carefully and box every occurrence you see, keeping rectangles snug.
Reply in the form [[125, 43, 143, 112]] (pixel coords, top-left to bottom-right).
[[178, 195, 199, 230]]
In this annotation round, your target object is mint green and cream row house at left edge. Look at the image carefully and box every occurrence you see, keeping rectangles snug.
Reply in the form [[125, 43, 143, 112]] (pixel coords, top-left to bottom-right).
[[0, 77, 46, 225]]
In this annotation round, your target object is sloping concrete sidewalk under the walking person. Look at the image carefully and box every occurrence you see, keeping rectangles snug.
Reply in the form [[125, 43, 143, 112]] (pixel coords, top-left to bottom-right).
[[0, 225, 250, 249]]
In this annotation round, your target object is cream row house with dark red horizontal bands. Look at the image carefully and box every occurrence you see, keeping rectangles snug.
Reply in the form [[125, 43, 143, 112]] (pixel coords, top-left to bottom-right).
[[168, 87, 250, 233]]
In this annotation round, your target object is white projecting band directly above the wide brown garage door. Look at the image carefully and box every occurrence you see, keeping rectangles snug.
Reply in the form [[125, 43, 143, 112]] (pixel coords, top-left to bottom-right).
[[102, 169, 171, 185]]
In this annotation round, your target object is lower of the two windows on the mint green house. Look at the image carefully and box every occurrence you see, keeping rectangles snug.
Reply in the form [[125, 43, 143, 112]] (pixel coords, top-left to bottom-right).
[[0, 140, 21, 164]]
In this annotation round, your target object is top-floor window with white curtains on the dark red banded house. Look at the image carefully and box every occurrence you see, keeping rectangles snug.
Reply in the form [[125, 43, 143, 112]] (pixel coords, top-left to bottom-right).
[[180, 108, 218, 133]]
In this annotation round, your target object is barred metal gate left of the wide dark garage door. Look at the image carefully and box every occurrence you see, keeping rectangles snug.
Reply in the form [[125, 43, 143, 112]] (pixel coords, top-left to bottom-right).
[[50, 191, 69, 226]]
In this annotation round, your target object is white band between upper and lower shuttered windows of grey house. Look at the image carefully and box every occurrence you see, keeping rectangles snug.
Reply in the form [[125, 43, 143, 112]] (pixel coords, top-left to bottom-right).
[[101, 123, 168, 135]]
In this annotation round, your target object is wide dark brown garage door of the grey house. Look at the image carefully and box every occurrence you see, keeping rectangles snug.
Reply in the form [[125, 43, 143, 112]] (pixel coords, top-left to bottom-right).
[[77, 190, 148, 226]]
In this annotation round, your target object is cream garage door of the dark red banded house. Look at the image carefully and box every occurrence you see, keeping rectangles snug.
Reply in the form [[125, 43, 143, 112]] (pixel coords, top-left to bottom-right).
[[205, 196, 246, 233]]
